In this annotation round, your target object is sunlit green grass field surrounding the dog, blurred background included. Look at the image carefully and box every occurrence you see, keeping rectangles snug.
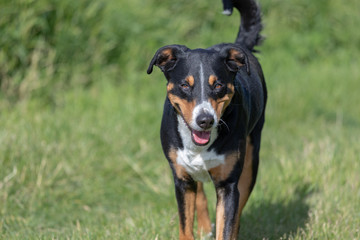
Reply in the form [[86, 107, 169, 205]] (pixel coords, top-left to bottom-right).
[[0, 0, 360, 239]]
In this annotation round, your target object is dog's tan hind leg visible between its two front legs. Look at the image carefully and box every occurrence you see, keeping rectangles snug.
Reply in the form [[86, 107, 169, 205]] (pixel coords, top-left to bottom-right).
[[196, 182, 211, 239]]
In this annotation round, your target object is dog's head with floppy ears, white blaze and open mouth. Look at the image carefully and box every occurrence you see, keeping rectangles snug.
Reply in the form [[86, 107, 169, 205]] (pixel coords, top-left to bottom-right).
[[147, 44, 249, 146]]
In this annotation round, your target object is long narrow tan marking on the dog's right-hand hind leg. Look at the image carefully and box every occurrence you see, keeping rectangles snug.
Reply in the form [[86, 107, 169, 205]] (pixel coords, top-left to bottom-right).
[[238, 137, 254, 214]]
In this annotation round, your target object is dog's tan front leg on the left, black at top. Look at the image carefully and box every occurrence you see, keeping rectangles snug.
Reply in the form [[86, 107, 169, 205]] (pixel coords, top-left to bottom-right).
[[175, 176, 196, 240]]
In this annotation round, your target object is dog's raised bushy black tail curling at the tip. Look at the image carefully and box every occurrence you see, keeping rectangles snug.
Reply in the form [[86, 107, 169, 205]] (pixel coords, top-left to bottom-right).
[[222, 0, 263, 51]]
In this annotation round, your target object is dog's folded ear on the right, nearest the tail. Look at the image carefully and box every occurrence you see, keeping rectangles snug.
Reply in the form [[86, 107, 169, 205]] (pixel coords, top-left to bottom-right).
[[220, 44, 250, 75]]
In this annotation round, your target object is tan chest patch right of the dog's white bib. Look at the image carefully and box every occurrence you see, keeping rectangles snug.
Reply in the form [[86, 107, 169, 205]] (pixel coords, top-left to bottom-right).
[[209, 152, 240, 182]]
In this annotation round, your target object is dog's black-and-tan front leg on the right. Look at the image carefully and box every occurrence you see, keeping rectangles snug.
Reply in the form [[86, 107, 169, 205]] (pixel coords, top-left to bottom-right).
[[216, 182, 240, 240]]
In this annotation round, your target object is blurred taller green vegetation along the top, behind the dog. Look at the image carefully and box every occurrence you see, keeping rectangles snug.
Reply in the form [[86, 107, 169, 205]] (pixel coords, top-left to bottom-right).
[[0, 0, 360, 102]]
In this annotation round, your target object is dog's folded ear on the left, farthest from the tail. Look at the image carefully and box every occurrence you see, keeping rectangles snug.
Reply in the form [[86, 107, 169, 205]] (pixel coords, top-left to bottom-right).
[[147, 45, 189, 74]]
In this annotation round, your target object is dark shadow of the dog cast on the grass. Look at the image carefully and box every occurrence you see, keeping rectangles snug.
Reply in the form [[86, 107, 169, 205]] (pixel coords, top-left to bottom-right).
[[240, 184, 313, 239]]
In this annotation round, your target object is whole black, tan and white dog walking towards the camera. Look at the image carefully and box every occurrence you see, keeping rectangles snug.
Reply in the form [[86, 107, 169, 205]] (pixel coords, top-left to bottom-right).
[[147, 0, 267, 239]]
